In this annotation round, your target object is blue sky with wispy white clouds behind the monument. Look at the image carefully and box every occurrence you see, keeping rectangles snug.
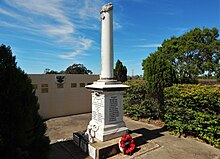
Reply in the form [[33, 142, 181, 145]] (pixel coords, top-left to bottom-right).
[[0, 0, 220, 75]]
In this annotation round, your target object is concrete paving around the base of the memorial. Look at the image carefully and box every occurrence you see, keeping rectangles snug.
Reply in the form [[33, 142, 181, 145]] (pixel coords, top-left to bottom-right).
[[46, 113, 220, 159]]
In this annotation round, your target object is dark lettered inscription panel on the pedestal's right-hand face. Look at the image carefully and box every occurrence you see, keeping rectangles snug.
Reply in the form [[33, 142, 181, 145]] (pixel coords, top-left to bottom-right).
[[109, 96, 119, 122]]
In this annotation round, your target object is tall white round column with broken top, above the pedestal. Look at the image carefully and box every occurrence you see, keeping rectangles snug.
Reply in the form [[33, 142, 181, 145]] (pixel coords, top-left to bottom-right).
[[100, 3, 114, 80]]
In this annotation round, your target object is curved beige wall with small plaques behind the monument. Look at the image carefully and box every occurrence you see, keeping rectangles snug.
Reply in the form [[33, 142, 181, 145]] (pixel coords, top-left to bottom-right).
[[29, 74, 99, 119]]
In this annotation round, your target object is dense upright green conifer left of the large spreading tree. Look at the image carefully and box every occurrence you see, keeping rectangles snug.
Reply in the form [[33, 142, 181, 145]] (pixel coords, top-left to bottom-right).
[[142, 52, 177, 117]]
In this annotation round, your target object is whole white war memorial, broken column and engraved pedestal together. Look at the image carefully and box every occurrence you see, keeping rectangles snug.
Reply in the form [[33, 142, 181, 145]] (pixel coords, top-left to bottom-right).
[[86, 3, 128, 143]]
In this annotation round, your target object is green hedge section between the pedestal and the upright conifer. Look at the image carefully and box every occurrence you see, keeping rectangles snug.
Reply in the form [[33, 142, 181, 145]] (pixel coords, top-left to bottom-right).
[[124, 81, 159, 120]]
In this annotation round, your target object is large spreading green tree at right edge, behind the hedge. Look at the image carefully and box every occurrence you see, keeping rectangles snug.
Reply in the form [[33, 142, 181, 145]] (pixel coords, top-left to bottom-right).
[[157, 28, 220, 83]]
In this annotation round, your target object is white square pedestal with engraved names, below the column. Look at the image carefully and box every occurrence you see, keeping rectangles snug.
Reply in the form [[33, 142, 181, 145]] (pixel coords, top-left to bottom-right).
[[86, 81, 128, 141]]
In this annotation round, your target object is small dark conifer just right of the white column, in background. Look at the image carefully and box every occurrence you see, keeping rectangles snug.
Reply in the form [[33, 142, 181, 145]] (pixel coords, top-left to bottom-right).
[[114, 60, 127, 82]]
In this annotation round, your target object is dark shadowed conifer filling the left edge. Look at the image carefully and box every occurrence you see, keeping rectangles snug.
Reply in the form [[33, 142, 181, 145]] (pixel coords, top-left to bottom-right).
[[0, 45, 49, 159]]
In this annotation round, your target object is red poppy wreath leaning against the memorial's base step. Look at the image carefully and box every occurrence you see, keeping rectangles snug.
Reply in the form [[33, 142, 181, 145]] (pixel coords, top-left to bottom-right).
[[119, 134, 135, 155]]
